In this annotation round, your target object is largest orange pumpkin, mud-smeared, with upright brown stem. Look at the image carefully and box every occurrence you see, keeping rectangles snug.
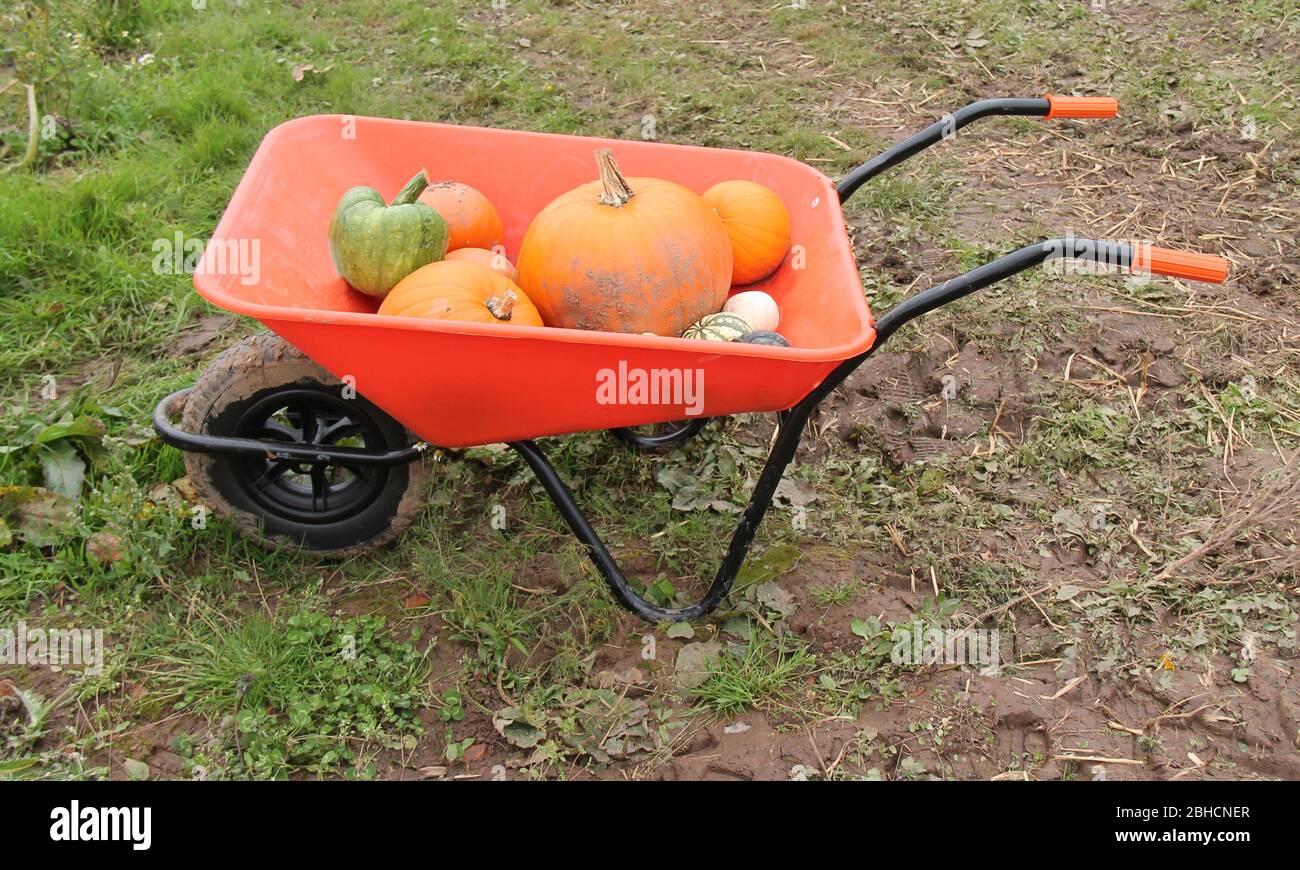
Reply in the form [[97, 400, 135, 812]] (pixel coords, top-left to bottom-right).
[[516, 148, 732, 336]]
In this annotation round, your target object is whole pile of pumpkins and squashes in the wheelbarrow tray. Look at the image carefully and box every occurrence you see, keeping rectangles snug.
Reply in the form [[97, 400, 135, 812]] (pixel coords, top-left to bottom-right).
[[329, 148, 790, 346]]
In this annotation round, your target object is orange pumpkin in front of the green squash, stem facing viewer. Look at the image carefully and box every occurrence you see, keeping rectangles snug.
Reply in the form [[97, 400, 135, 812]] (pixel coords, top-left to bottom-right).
[[380, 260, 542, 326]]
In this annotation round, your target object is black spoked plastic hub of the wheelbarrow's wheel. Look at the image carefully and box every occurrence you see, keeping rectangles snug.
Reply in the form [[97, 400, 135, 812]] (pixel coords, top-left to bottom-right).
[[233, 386, 389, 524]]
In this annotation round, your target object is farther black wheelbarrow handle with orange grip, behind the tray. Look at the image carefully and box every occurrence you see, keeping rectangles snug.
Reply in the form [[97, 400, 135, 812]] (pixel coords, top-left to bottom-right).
[[836, 94, 1119, 203]]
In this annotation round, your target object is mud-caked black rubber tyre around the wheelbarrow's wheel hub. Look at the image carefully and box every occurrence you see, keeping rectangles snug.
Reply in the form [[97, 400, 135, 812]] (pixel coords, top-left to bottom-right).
[[181, 333, 429, 558]]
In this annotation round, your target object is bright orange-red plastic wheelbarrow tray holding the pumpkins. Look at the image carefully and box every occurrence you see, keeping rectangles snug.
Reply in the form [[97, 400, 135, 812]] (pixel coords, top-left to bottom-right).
[[195, 114, 875, 447]]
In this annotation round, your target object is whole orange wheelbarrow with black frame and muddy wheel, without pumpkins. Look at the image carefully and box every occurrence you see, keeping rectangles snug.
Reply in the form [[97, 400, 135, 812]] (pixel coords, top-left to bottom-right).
[[153, 96, 1227, 622]]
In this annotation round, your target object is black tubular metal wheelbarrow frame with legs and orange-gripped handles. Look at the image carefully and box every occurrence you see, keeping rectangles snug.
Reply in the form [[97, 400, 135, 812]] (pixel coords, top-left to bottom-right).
[[153, 95, 1227, 622]]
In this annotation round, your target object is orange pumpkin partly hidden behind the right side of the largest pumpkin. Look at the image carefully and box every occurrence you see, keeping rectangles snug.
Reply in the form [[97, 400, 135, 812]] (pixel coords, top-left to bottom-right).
[[705, 181, 790, 285]]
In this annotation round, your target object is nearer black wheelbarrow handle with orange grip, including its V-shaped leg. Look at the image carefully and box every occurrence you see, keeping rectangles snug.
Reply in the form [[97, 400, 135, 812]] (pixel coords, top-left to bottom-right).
[[510, 237, 1227, 623]]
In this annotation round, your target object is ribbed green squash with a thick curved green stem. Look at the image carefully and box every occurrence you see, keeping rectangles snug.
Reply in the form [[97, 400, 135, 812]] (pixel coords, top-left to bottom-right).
[[329, 169, 449, 297]]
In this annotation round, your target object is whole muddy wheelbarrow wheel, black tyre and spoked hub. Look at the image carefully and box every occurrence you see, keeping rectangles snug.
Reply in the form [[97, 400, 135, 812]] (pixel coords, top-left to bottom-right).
[[182, 333, 429, 557]]
